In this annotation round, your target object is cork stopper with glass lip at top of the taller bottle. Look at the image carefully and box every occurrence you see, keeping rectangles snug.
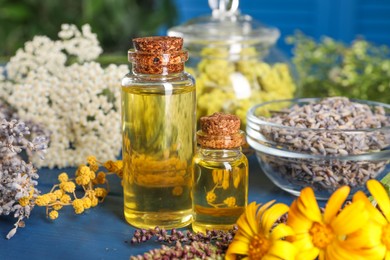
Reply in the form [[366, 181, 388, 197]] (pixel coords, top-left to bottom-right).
[[128, 36, 188, 75]]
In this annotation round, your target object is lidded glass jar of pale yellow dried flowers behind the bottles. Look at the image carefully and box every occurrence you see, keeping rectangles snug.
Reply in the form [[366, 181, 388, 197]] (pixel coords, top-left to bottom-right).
[[168, 0, 296, 129]]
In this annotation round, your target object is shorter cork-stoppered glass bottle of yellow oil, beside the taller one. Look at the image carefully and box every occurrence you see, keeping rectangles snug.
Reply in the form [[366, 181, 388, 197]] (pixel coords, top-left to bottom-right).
[[192, 113, 248, 232]]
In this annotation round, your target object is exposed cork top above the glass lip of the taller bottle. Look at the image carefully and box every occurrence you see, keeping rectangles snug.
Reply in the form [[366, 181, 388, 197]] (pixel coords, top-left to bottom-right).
[[133, 36, 183, 53]]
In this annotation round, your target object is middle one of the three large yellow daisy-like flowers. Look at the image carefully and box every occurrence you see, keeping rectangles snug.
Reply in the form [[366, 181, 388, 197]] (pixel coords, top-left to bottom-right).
[[287, 186, 368, 260]]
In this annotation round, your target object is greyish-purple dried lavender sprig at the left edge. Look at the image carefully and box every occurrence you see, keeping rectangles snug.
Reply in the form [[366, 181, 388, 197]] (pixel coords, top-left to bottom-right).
[[0, 120, 46, 239]]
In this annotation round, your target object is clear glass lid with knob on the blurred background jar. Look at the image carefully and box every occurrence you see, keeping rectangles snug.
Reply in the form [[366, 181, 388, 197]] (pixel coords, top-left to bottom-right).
[[168, 0, 280, 47]]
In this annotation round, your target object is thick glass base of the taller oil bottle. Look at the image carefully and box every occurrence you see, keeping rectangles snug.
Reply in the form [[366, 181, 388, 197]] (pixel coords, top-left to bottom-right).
[[125, 209, 192, 229]]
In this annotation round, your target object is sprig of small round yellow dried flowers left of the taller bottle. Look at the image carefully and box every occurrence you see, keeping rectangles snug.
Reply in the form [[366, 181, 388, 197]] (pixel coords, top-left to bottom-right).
[[34, 156, 123, 220]]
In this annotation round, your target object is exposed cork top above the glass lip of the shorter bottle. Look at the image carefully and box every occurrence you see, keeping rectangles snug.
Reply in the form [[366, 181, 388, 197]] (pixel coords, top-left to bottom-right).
[[200, 112, 241, 135]]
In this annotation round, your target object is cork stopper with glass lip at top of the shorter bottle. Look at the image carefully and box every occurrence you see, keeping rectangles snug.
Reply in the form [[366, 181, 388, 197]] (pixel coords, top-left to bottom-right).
[[197, 113, 245, 149]]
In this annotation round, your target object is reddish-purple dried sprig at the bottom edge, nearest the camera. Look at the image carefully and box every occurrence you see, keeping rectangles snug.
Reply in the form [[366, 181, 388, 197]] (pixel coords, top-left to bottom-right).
[[130, 241, 224, 260]]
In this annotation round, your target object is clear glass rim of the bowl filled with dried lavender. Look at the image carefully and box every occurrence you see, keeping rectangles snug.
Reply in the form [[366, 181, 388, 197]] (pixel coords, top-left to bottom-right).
[[246, 97, 390, 133]]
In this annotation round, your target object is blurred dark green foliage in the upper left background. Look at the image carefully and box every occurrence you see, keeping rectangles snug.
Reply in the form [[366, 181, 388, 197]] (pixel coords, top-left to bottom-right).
[[0, 0, 177, 60]]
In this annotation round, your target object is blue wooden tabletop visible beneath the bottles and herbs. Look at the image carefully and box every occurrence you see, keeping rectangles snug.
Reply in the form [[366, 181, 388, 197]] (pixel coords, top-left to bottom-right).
[[0, 155, 295, 260]]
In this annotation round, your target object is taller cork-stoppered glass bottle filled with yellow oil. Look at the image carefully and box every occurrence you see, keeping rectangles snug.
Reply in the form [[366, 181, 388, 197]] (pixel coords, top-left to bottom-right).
[[121, 36, 196, 228]]
